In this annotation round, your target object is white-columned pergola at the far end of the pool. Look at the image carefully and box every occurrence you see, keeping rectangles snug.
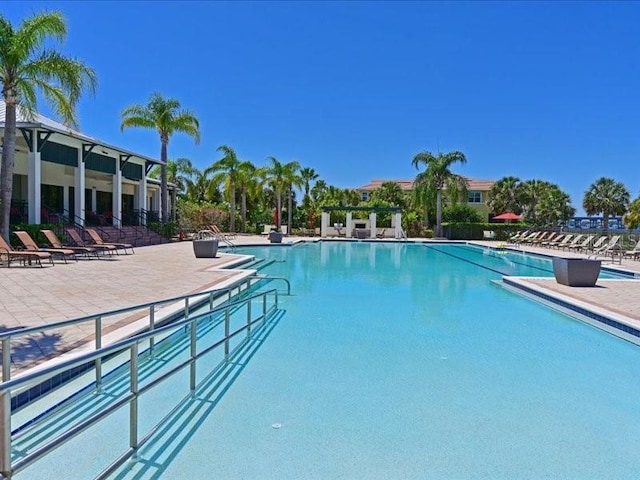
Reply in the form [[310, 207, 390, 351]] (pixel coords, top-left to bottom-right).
[[320, 206, 404, 238]]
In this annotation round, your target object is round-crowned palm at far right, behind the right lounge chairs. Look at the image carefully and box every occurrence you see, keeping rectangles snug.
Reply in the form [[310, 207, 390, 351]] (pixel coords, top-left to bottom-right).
[[582, 177, 630, 234]]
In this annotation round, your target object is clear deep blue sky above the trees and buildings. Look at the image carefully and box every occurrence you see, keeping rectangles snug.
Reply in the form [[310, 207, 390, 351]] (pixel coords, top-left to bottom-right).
[[1, 0, 640, 211]]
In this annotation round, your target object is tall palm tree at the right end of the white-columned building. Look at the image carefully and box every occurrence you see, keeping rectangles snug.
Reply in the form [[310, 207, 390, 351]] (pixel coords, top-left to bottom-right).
[[120, 93, 200, 223]]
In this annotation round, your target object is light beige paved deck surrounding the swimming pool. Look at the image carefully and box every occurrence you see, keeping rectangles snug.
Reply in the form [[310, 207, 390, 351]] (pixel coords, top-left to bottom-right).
[[0, 235, 640, 376]]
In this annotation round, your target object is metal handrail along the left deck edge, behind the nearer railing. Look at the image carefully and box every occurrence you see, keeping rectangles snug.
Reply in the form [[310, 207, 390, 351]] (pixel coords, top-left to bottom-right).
[[0, 277, 258, 382]]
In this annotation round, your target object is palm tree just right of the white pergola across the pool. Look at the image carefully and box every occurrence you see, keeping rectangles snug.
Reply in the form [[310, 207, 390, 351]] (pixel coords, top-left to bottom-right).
[[411, 151, 467, 237]]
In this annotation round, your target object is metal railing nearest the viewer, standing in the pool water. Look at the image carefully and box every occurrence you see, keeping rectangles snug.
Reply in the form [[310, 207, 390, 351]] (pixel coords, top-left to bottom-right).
[[0, 290, 278, 479]]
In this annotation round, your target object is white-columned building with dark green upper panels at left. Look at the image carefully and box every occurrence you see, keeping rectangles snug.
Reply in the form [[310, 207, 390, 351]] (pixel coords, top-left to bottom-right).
[[0, 100, 166, 226]]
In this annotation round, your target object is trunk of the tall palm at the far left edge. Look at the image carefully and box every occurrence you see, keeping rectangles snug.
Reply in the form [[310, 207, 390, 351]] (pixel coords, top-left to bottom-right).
[[0, 101, 17, 243]]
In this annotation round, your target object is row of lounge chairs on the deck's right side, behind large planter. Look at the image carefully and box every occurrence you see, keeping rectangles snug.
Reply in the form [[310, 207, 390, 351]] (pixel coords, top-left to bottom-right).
[[509, 231, 640, 261]]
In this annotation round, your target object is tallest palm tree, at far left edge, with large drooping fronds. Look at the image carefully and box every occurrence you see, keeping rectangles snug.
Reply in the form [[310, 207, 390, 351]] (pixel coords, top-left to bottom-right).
[[0, 12, 97, 242]]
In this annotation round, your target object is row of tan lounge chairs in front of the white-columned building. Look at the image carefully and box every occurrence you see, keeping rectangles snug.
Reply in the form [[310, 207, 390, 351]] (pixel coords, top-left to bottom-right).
[[0, 228, 135, 267]]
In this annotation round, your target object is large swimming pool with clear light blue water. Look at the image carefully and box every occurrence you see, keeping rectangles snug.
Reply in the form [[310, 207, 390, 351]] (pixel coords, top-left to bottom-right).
[[19, 242, 640, 479]]
